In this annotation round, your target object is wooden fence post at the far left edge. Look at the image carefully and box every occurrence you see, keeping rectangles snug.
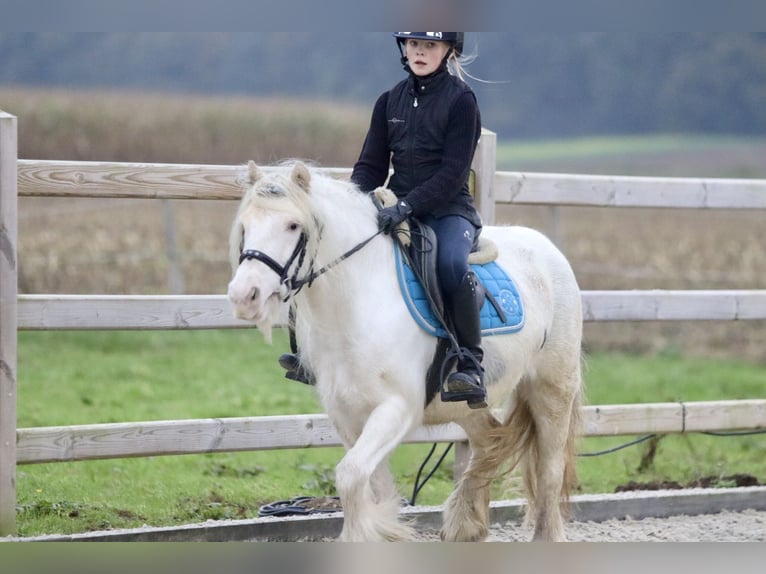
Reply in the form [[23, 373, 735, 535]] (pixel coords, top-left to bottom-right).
[[0, 110, 18, 536]]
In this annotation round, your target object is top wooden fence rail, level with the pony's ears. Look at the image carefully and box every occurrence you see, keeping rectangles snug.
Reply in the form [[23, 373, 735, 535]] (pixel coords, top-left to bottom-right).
[[18, 159, 766, 210]]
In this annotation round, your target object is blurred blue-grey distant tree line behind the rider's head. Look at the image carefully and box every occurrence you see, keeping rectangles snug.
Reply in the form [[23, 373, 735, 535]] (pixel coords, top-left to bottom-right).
[[0, 32, 766, 138]]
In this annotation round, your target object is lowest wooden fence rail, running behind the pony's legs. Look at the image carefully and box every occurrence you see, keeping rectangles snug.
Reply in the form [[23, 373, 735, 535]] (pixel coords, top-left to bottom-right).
[[17, 399, 766, 464]]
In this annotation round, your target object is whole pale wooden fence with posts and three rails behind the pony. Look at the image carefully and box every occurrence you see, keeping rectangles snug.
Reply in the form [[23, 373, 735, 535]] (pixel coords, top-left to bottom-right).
[[0, 116, 766, 536]]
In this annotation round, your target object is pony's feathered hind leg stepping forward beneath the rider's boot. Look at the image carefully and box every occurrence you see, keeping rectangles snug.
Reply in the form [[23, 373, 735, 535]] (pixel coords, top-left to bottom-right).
[[439, 409, 502, 542]]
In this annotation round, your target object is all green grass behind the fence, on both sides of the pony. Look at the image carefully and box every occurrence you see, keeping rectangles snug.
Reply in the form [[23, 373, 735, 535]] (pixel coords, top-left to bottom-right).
[[12, 330, 766, 536]]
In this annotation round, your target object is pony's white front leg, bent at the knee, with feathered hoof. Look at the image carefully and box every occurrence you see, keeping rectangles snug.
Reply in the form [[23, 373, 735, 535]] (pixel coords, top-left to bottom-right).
[[335, 396, 416, 542]]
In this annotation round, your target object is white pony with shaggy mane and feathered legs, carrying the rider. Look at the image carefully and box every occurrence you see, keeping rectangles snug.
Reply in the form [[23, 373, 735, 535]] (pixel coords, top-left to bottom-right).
[[228, 162, 582, 541]]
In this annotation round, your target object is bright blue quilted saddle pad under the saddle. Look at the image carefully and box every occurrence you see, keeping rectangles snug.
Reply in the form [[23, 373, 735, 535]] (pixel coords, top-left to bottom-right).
[[395, 245, 524, 338]]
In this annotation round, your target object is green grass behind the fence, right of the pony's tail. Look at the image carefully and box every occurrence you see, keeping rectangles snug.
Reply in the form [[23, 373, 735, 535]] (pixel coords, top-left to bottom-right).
[[578, 353, 766, 493]]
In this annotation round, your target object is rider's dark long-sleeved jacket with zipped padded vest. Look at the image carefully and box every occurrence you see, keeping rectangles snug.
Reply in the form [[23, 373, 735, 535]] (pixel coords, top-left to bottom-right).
[[351, 69, 481, 227]]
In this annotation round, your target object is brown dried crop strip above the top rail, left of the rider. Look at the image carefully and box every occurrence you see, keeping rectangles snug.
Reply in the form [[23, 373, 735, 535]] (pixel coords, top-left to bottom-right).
[[0, 88, 369, 165]]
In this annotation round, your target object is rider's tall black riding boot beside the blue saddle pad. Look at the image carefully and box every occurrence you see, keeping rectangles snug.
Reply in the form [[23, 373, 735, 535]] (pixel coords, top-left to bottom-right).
[[441, 271, 487, 409]]
